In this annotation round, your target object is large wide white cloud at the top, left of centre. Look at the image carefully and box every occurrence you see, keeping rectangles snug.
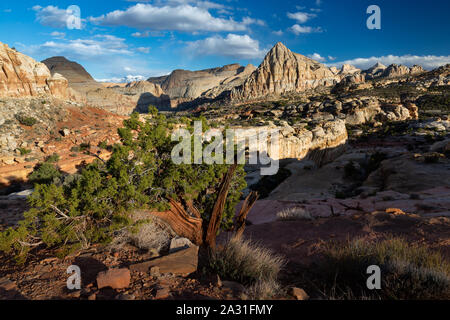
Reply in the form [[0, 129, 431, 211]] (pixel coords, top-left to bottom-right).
[[89, 1, 260, 32]]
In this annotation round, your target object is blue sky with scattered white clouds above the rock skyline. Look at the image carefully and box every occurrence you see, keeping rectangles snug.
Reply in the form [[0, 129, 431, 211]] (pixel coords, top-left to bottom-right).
[[0, 0, 450, 81]]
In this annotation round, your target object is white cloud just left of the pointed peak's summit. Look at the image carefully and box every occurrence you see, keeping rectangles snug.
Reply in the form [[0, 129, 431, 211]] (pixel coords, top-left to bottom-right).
[[187, 34, 266, 59]]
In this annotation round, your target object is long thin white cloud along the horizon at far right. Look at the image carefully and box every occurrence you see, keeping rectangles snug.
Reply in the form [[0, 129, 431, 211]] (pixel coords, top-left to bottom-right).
[[331, 54, 450, 69]]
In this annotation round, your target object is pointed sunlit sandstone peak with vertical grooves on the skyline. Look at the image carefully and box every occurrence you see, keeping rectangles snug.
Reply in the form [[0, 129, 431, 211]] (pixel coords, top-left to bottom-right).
[[231, 42, 340, 100]]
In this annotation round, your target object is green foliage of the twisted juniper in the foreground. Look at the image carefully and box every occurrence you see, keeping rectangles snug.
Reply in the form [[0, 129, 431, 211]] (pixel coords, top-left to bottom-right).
[[0, 110, 246, 262]]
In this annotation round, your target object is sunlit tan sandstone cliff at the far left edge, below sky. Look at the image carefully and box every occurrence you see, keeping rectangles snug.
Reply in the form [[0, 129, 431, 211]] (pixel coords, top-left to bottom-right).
[[0, 42, 69, 99]]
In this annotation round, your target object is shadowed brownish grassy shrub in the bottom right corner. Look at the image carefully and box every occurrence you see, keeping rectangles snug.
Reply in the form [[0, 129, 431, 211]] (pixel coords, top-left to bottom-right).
[[316, 238, 450, 299]]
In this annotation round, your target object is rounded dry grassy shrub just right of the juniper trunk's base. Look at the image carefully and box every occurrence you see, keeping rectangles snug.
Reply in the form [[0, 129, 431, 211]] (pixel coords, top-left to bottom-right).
[[209, 238, 284, 285]]
